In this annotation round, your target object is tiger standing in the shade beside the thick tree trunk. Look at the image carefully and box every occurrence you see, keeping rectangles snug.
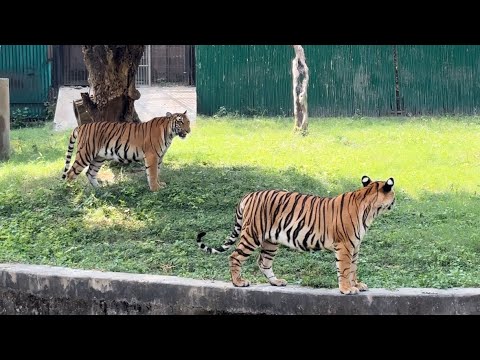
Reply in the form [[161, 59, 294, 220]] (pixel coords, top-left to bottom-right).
[[62, 111, 190, 191]]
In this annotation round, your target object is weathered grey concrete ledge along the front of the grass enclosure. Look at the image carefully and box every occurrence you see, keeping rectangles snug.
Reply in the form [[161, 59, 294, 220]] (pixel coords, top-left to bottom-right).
[[0, 264, 480, 315]]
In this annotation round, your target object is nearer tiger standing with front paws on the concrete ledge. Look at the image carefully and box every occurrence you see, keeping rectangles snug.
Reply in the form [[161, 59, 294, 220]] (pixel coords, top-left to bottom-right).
[[197, 176, 395, 294]]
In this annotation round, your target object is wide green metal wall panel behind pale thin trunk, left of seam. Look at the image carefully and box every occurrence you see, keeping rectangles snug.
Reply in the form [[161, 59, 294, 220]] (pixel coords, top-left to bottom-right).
[[196, 45, 395, 116]]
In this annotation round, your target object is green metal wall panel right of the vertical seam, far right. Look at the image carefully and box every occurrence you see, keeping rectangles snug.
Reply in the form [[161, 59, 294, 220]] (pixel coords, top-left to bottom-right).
[[398, 45, 480, 115]]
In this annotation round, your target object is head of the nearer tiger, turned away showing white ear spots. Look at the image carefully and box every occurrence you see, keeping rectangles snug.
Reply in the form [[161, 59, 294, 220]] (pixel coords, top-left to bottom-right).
[[362, 175, 395, 217]]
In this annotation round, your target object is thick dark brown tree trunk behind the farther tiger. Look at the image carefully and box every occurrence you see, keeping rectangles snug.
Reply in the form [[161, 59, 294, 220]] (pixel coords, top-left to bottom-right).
[[81, 45, 145, 122]]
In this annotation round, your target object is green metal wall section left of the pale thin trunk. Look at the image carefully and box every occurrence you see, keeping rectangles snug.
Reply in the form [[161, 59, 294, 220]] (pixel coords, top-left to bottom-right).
[[195, 45, 293, 115]]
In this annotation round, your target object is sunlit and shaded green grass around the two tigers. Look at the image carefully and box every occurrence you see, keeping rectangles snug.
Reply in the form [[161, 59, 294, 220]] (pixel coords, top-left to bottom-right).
[[0, 117, 480, 288]]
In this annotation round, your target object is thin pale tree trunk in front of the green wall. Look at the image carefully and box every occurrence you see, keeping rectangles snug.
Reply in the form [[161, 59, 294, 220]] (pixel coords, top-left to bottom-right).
[[292, 45, 308, 135]]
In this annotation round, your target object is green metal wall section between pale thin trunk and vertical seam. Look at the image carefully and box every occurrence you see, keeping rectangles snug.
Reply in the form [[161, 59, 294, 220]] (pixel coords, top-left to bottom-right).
[[306, 45, 395, 116]]
